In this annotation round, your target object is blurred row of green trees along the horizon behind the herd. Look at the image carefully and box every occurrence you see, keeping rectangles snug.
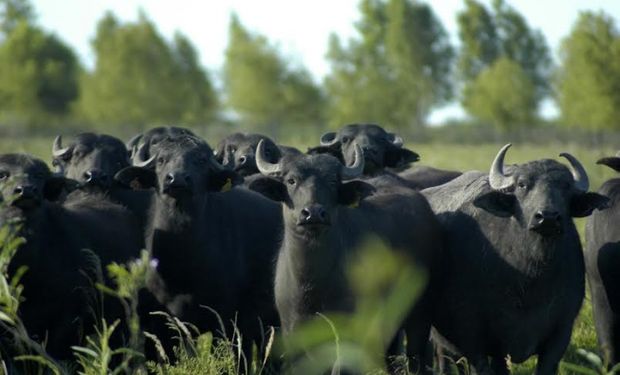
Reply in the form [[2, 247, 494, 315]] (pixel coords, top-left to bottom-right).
[[0, 0, 620, 134]]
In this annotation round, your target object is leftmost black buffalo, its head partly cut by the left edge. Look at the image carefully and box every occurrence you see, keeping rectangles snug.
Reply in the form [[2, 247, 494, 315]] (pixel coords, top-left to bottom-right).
[[0, 154, 139, 359]]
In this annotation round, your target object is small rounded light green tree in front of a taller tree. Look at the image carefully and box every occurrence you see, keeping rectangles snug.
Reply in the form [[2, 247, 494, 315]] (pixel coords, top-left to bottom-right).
[[464, 57, 536, 130]]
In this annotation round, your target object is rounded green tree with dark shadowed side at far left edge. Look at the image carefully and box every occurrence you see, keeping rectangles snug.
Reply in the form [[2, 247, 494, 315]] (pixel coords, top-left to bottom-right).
[[0, 21, 79, 126]]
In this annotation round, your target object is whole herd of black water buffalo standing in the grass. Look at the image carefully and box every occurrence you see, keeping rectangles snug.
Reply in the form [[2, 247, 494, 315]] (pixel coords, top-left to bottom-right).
[[0, 124, 620, 375]]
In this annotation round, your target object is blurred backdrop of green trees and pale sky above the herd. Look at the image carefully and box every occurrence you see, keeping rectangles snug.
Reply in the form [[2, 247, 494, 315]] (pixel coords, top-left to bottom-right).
[[0, 0, 620, 145]]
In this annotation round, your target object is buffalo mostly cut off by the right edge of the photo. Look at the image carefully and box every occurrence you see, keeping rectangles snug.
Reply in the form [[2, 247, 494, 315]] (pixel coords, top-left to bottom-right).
[[585, 153, 620, 365]]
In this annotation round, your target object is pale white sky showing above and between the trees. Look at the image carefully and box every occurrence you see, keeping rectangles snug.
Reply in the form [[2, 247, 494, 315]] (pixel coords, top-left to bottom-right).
[[32, 0, 620, 123]]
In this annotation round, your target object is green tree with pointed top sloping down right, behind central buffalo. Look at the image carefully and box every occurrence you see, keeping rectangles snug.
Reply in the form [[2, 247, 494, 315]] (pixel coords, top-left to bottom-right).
[[223, 15, 324, 131]]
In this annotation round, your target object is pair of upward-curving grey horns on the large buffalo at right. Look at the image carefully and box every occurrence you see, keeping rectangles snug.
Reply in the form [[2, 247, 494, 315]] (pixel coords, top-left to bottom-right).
[[489, 143, 590, 192]]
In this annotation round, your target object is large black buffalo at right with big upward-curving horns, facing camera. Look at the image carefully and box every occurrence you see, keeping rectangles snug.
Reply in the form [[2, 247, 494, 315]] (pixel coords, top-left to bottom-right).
[[422, 145, 607, 375]]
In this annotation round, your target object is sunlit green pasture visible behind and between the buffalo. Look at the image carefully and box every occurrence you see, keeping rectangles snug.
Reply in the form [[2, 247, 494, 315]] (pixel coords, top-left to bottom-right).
[[0, 138, 616, 374]]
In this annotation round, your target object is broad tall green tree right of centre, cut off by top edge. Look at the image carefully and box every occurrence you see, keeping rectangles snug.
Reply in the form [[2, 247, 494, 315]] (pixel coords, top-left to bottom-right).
[[325, 0, 453, 128]]
